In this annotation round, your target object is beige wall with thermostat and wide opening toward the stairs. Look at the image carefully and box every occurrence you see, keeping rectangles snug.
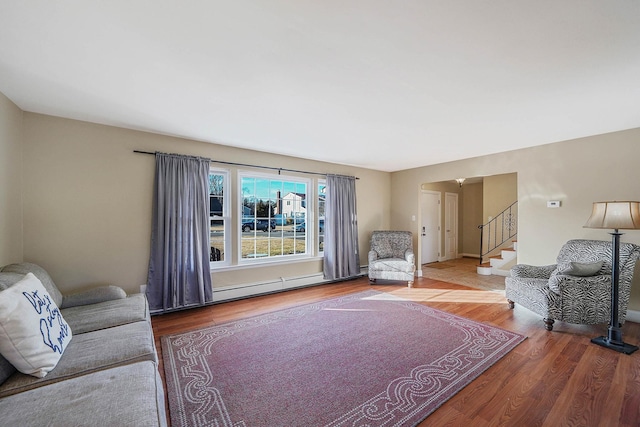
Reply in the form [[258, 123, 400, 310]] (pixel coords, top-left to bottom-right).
[[391, 128, 640, 310]]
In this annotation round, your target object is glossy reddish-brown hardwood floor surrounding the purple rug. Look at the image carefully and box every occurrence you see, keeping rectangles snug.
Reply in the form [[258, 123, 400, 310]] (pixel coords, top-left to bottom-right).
[[152, 277, 640, 427]]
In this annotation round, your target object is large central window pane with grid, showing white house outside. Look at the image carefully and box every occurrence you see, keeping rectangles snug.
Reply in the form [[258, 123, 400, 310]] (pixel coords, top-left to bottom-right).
[[239, 173, 312, 262]]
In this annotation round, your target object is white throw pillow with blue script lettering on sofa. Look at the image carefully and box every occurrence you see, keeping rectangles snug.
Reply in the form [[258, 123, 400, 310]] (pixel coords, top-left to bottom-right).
[[0, 273, 71, 378]]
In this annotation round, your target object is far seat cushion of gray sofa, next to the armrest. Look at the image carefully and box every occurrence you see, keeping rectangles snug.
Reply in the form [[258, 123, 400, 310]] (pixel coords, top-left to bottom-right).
[[61, 294, 150, 335]]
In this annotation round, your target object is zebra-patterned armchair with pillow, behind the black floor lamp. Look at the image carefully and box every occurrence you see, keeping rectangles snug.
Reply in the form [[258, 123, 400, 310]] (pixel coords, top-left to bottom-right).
[[505, 239, 640, 331]]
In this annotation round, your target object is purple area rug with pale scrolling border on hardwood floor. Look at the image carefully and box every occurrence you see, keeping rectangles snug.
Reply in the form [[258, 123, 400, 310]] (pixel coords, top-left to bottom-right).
[[162, 291, 525, 427]]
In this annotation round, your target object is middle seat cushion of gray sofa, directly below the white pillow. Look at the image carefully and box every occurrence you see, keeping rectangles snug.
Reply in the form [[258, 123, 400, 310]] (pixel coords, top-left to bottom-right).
[[0, 321, 158, 397]]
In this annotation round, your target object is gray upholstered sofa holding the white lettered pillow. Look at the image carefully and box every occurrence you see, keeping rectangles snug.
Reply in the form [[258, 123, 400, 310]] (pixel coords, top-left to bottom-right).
[[0, 263, 167, 426]]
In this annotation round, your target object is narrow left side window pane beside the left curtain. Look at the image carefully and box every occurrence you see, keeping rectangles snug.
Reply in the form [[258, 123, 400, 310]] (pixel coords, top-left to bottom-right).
[[209, 168, 231, 267]]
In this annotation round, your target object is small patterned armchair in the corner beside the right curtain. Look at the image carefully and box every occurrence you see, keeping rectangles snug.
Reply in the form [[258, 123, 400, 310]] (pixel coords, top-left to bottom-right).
[[369, 230, 416, 287]]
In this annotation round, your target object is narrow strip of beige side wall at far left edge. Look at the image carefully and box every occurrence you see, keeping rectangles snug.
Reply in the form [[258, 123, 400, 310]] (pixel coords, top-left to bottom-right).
[[0, 93, 23, 266]]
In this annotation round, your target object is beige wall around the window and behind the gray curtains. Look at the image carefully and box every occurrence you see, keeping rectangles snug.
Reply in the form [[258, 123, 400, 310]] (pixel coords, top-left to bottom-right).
[[23, 113, 390, 293]]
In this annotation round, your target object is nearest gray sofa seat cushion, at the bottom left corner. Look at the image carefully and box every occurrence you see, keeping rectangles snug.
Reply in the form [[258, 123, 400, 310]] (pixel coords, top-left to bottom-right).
[[0, 362, 167, 427]]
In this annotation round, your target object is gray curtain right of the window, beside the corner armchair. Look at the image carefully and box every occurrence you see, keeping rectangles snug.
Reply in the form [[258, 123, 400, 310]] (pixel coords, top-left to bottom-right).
[[323, 175, 360, 280]]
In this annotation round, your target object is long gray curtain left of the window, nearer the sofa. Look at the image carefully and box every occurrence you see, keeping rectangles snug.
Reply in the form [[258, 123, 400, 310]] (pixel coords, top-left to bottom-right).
[[146, 153, 213, 312]]
